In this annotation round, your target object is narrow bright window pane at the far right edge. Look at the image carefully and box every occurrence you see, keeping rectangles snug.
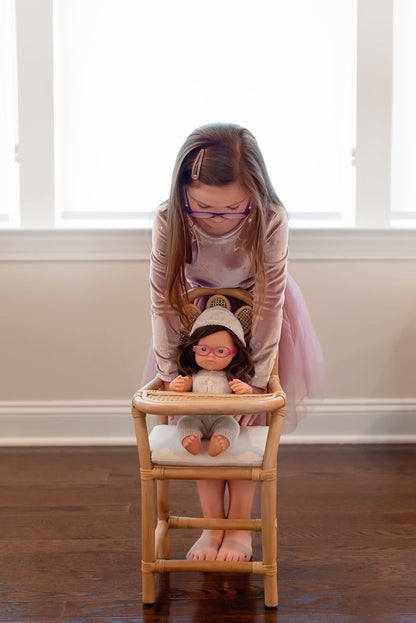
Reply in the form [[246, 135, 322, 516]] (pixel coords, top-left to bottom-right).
[[391, 0, 416, 227]]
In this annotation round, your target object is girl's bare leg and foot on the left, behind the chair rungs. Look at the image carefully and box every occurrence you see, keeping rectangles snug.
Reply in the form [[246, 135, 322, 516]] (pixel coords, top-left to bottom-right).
[[186, 480, 225, 560]]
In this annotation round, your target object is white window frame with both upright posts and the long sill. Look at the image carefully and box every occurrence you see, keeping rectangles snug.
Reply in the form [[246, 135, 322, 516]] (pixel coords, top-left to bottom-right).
[[0, 0, 416, 259]]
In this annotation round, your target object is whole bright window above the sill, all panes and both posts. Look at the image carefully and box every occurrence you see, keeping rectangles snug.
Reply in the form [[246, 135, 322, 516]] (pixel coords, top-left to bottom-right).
[[0, 0, 416, 234]]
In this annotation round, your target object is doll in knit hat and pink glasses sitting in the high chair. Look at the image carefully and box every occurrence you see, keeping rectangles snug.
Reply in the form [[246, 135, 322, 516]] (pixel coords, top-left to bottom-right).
[[169, 307, 254, 456]]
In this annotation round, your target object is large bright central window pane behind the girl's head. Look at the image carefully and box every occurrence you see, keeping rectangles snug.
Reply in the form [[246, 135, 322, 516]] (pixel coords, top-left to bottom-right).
[[54, 0, 355, 227]]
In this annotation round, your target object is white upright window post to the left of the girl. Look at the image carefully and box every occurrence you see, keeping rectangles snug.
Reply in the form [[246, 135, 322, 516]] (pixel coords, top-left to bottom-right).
[[16, 0, 54, 229]]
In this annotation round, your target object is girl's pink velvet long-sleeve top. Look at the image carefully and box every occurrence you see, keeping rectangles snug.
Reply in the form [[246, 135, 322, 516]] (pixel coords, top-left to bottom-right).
[[150, 204, 288, 388]]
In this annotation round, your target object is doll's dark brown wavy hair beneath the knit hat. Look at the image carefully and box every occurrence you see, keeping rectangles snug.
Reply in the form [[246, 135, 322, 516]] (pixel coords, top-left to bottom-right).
[[178, 325, 254, 383]]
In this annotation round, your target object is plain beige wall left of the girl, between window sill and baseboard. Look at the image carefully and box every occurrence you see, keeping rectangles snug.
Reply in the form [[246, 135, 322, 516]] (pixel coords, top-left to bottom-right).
[[0, 262, 150, 401]]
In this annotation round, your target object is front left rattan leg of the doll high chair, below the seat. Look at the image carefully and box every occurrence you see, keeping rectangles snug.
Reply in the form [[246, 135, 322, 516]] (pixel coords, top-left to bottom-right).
[[141, 480, 155, 604]]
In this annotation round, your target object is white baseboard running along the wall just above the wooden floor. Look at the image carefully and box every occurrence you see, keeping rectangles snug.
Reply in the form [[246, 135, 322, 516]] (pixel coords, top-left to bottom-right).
[[0, 398, 416, 446]]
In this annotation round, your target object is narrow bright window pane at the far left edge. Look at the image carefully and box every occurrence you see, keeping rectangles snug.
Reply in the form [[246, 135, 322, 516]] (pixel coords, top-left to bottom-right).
[[0, 0, 19, 227]]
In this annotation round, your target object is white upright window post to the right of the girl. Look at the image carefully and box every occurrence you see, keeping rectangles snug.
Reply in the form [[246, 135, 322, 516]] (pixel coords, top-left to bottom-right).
[[355, 0, 393, 227]]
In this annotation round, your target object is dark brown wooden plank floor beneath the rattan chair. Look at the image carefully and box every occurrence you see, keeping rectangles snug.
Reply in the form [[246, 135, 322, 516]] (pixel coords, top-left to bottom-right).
[[0, 445, 416, 623]]
